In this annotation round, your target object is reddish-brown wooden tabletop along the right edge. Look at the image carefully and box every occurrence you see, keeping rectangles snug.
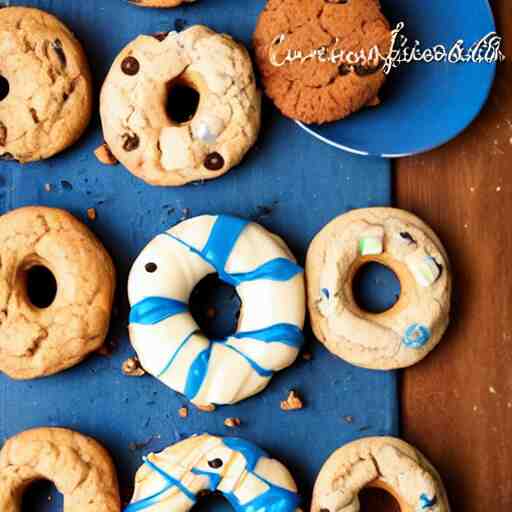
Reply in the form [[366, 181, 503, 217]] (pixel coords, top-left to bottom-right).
[[395, 0, 512, 512]]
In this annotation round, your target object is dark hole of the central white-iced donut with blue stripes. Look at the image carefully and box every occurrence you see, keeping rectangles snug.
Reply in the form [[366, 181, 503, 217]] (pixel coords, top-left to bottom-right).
[[189, 274, 242, 340]]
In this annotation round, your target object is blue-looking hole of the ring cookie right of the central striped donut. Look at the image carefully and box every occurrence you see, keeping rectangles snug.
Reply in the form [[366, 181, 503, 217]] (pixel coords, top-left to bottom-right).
[[352, 261, 401, 314]]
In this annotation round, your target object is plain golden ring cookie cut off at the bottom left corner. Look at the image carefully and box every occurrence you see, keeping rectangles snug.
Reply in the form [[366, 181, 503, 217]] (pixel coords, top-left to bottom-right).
[[0, 428, 121, 512]]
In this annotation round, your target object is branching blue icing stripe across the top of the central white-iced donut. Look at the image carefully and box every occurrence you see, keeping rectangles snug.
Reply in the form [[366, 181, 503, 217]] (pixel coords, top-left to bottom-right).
[[164, 215, 303, 286]]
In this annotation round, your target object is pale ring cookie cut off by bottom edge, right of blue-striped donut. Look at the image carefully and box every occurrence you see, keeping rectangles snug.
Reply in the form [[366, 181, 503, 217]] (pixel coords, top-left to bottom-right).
[[311, 437, 450, 512]]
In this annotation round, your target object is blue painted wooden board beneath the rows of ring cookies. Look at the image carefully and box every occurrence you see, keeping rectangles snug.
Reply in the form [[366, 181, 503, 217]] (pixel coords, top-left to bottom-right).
[[0, 0, 398, 511]]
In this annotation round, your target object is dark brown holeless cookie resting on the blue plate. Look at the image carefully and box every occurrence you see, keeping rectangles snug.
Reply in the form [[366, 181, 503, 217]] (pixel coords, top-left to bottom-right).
[[253, 0, 391, 123]]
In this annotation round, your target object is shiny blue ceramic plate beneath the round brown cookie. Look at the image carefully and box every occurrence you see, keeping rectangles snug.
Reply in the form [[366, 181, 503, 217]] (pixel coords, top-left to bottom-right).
[[299, 0, 496, 158]]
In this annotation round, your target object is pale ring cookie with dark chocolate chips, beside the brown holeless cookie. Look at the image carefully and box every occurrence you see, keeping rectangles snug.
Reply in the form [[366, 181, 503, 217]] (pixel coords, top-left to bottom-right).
[[101, 25, 261, 186]]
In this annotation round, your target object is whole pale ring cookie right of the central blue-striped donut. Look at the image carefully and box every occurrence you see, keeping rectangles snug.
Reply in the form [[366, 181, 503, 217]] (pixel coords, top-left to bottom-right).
[[306, 208, 452, 370]]
